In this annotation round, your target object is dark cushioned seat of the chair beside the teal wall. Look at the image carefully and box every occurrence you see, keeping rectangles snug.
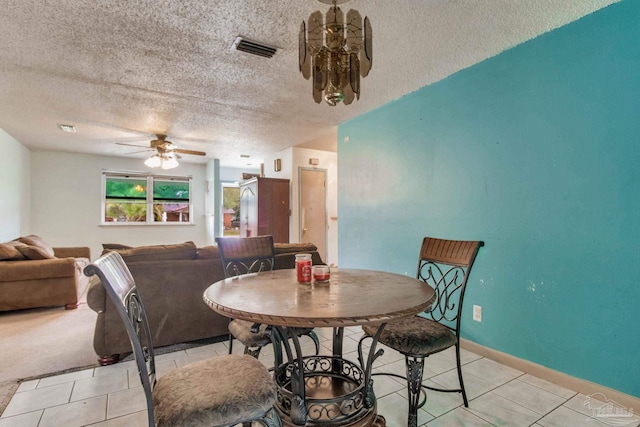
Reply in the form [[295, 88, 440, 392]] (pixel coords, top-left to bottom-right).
[[362, 316, 456, 355]]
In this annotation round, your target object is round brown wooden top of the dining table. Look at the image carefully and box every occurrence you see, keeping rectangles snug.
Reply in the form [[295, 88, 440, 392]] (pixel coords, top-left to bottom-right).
[[203, 269, 435, 327]]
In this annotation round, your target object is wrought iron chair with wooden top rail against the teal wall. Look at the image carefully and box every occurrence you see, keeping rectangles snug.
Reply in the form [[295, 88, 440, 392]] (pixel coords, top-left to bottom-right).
[[360, 237, 484, 427]]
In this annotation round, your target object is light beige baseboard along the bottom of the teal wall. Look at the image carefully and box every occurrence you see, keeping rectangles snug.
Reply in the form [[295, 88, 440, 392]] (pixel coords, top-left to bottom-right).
[[460, 338, 640, 414]]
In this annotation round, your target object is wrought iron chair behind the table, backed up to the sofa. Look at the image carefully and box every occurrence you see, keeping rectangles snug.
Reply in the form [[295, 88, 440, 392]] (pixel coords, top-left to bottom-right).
[[216, 236, 320, 358]]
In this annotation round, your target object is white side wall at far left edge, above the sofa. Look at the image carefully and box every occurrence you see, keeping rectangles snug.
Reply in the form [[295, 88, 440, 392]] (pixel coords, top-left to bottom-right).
[[0, 129, 30, 242]]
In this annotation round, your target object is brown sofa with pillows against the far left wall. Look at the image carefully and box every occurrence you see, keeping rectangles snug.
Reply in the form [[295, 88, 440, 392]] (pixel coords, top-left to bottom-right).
[[0, 235, 91, 311]]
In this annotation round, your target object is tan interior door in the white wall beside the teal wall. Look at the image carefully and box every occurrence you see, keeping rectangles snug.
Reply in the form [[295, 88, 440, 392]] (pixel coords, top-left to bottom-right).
[[300, 168, 327, 262]]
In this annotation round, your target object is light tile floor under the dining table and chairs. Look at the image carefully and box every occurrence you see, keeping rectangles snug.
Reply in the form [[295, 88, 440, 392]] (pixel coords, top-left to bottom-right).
[[0, 327, 640, 427]]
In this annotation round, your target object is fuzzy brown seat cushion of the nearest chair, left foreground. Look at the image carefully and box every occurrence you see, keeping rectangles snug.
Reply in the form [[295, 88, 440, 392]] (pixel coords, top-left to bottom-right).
[[153, 355, 275, 427]]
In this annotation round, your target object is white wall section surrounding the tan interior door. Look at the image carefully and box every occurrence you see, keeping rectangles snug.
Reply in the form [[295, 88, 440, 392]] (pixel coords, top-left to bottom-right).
[[264, 147, 338, 265]]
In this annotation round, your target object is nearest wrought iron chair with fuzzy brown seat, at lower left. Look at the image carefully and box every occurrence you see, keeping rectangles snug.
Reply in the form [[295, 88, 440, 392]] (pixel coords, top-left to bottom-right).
[[84, 252, 282, 427]]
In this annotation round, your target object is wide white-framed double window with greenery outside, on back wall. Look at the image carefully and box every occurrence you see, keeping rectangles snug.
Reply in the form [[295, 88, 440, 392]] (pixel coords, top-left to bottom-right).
[[102, 172, 192, 224]]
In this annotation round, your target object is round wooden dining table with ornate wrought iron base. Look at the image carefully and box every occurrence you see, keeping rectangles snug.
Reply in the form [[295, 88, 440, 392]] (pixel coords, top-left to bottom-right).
[[203, 268, 435, 427]]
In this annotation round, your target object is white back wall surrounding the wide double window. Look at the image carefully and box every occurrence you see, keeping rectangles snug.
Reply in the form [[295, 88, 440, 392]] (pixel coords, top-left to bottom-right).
[[30, 151, 207, 259]]
